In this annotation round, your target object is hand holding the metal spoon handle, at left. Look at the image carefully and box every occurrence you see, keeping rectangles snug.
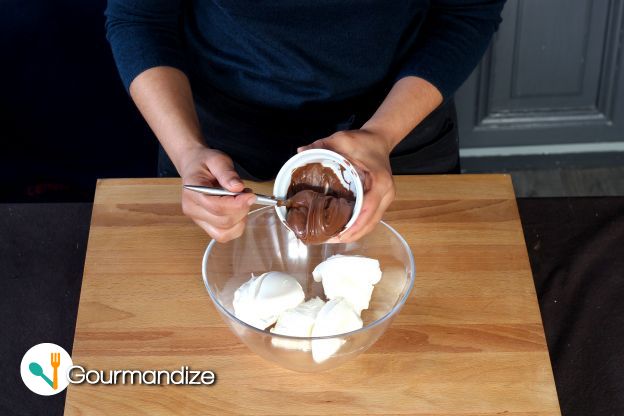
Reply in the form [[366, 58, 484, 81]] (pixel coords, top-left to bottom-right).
[[178, 146, 256, 243]]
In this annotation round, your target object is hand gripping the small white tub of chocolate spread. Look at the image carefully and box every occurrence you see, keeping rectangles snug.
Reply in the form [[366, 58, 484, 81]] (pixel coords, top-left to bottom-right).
[[297, 129, 395, 243]]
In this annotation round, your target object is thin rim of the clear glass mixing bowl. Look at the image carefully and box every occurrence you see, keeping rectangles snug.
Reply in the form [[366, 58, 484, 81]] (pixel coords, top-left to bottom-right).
[[202, 206, 416, 341]]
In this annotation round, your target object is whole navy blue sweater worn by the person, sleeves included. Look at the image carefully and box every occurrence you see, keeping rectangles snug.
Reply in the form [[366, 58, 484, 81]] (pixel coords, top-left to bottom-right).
[[106, 0, 504, 109]]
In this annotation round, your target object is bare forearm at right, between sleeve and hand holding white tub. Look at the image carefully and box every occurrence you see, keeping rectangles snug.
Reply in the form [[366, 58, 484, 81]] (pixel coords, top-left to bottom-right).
[[362, 76, 442, 153]]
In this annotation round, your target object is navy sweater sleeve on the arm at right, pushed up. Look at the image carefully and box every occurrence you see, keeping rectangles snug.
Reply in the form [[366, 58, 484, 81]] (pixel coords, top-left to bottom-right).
[[397, 0, 505, 99]]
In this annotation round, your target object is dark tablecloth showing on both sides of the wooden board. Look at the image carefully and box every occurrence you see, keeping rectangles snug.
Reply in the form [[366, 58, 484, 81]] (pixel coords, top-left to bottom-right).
[[0, 197, 624, 416]]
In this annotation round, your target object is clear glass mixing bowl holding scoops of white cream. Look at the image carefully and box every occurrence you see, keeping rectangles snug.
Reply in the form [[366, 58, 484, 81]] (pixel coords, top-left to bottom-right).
[[202, 207, 415, 372]]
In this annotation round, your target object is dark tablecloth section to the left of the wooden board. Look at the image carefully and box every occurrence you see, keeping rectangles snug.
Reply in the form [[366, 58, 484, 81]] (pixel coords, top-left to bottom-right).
[[0, 203, 91, 416]]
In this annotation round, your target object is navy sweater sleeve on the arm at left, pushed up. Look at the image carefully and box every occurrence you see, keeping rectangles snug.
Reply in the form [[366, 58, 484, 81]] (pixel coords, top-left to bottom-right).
[[105, 0, 185, 90]]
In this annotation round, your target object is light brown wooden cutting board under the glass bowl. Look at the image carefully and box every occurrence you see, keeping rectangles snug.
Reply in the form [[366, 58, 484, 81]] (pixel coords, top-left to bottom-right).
[[65, 175, 560, 416]]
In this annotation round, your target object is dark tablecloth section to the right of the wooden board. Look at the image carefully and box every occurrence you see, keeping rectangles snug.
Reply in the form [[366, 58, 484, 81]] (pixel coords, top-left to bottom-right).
[[518, 197, 624, 416]]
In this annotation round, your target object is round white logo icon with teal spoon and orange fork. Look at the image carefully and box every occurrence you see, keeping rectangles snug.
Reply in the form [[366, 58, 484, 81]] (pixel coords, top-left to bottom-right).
[[20, 343, 73, 396]]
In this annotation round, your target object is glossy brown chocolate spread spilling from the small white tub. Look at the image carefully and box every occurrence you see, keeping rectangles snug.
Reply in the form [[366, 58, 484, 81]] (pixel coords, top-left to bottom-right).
[[286, 163, 355, 244]]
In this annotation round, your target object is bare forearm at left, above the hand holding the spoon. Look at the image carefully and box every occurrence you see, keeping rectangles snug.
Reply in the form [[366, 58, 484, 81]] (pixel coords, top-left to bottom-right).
[[130, 66, 205, 172]]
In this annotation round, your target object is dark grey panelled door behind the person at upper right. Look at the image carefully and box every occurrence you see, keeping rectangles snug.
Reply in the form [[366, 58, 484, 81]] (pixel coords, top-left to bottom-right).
[[456, 0, 624, 166]]
